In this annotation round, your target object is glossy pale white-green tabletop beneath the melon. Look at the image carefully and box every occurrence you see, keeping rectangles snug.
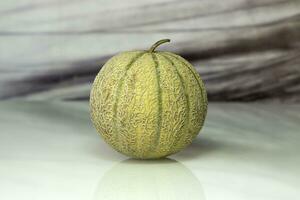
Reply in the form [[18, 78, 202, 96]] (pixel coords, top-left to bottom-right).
[[0, 101, 300, 200]]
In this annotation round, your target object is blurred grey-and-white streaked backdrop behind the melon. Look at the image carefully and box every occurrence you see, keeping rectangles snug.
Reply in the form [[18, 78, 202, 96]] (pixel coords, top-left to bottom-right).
[[0, 0, 300, 103]]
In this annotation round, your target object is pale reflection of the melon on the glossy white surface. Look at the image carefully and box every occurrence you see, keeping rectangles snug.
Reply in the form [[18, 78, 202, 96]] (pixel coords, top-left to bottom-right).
[[94, 159, 204, 200]]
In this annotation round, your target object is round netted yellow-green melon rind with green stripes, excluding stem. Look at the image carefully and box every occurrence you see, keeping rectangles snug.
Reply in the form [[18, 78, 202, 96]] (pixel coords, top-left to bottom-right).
[[90, 39, 207, 159]]
